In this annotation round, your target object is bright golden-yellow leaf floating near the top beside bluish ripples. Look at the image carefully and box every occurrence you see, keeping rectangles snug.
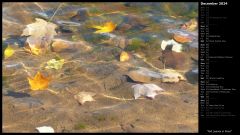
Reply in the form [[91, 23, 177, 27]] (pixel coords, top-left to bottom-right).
[[92, 22, 117, 33]]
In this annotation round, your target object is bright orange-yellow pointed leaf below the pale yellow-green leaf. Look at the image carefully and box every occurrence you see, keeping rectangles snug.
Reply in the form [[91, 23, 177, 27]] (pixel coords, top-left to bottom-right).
[[28, 72, 50, 90]]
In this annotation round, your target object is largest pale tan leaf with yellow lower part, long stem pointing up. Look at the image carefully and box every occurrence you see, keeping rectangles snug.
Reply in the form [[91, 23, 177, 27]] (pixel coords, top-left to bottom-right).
[[22, 18, 57, 55]]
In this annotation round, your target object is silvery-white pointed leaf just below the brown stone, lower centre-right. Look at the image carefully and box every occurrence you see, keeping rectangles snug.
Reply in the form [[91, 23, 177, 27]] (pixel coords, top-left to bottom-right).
[[132, 84, 164, 99]]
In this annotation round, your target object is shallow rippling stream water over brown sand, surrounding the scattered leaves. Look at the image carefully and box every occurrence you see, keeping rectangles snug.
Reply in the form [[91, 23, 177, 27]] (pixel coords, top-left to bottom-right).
[[2, 2, 198, 132]]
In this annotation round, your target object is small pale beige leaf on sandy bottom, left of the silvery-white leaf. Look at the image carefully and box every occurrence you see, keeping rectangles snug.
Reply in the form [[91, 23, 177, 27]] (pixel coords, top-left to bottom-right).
[[74, 92, 96, 105]]
